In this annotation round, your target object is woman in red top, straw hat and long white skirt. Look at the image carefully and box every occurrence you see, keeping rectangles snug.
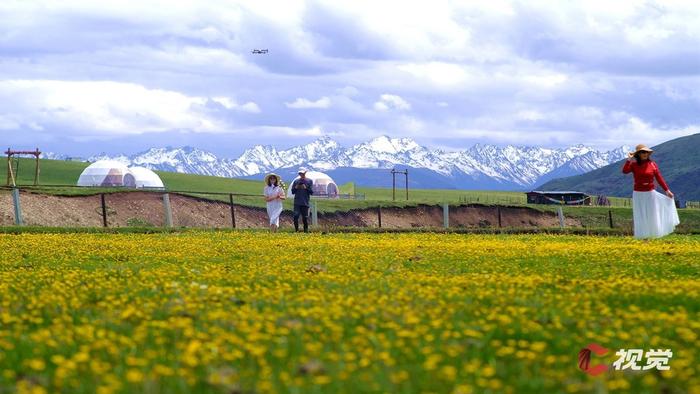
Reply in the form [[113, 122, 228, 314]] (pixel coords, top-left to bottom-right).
[[622, 144, 680, 239]]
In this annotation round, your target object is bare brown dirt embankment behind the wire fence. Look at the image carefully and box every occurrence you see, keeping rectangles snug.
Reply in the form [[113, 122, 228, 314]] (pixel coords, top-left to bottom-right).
[[0, 192, 581, 228]]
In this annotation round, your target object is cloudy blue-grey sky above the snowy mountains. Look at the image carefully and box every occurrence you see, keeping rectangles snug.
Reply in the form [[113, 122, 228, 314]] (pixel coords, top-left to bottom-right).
[[0, 0, 700, 156]]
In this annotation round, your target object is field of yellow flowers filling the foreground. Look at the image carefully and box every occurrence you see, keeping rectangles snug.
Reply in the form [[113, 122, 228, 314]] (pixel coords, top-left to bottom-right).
[[0, 232, 700, 393]]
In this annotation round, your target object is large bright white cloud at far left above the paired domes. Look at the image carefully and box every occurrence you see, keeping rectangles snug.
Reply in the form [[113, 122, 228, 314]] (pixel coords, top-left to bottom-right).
[[0, 80, 230, 134]]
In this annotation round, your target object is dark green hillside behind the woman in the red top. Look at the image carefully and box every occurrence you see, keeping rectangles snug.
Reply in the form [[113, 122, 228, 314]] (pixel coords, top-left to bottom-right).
[[540, 134, 700, 201]]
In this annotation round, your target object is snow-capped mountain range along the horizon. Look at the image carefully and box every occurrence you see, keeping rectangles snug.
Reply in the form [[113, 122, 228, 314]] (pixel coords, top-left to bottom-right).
[[89, 136, 629, 190]]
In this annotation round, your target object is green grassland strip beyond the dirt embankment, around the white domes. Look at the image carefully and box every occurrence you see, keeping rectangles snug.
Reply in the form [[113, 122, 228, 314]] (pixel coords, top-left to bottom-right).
[[5, 159, 700, 231]]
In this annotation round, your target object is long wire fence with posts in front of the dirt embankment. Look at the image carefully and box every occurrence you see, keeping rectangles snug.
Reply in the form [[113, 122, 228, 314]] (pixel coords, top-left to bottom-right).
[[0, 185, 700, 231]]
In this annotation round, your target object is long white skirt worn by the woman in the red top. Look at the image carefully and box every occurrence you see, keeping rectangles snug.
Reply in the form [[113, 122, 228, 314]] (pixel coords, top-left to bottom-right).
[[632, 190, 680, 239]]
